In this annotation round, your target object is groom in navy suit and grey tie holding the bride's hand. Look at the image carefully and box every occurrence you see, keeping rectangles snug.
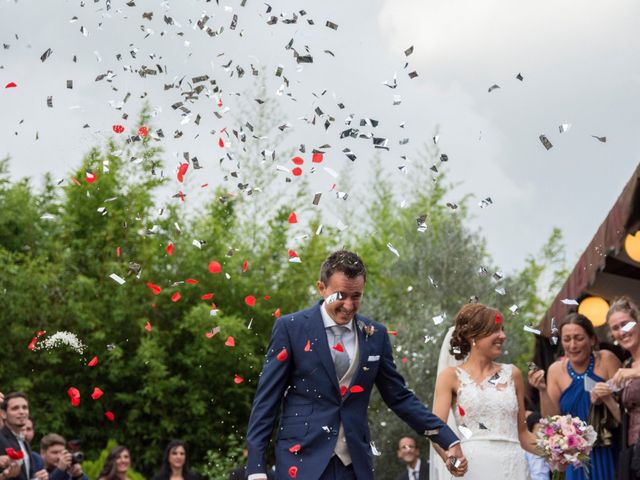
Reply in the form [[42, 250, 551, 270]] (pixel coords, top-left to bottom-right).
[[247, 250, 467, 480]]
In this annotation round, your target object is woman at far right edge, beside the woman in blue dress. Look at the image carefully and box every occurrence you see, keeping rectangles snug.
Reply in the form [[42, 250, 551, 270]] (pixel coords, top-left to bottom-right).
[[607, 297, 640, 480]]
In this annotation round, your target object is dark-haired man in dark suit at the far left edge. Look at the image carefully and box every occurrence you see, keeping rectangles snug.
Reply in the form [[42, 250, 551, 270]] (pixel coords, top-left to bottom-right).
[[0, 392, 49, 480]]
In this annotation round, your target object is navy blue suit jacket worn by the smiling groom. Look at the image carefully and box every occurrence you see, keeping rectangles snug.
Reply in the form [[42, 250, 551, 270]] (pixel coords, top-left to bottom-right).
[[242, 302, 457, 480]]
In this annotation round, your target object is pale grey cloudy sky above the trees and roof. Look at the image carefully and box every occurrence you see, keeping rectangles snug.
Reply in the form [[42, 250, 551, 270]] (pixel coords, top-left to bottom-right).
[[0, 0, 640, 271]]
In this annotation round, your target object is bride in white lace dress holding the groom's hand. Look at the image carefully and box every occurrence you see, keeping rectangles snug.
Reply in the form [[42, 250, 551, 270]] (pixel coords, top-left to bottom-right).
[[431, 303, 539, 480]]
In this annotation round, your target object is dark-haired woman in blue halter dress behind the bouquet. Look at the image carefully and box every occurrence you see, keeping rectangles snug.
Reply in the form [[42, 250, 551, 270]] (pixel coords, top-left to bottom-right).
[[529, 313, 620, 480]]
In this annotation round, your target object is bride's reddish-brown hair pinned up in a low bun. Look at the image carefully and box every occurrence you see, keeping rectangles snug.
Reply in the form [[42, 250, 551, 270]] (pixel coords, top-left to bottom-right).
[[449, 303, 502, 360]]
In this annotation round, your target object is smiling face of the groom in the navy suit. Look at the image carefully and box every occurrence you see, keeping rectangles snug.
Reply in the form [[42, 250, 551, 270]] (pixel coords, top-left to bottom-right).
[[317, 272, 365, 325]]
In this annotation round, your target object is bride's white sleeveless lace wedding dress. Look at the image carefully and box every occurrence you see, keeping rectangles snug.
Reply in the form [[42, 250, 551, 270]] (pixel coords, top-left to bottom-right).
[[453, 364, 529, 480]]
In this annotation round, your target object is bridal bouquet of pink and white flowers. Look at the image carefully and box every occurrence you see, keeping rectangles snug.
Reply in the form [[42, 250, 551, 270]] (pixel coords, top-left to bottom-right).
[[537, 415, 597, 480]]
